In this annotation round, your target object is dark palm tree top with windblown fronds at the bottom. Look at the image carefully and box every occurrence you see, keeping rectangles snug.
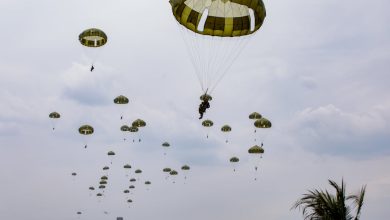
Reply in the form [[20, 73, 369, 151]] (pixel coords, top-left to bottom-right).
[[291, 180, 366, 220]]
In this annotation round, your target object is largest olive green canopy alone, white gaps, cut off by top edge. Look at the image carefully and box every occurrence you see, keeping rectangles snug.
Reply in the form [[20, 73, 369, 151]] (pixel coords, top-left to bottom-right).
[[170, 0, 266, 37]]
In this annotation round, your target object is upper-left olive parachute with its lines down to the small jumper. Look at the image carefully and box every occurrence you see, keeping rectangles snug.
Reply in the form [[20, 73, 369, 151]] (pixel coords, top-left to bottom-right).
[[79, 28, 107, 72]]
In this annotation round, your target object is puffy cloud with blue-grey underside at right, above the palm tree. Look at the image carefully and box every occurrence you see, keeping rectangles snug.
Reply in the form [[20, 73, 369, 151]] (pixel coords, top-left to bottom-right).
[[289, 104, 390, 158]]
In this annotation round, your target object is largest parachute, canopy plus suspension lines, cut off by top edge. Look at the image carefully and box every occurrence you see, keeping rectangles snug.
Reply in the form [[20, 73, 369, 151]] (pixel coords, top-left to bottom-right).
[[170, 0, 266, 94]]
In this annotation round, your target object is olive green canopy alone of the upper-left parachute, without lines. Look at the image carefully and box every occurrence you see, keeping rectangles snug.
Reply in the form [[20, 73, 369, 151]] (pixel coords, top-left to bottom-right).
[[79, 28, 107, 47]]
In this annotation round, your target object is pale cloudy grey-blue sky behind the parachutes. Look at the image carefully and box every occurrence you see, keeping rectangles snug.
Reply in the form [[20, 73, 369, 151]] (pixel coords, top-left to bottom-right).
[[0, 0, 390, 220]]
